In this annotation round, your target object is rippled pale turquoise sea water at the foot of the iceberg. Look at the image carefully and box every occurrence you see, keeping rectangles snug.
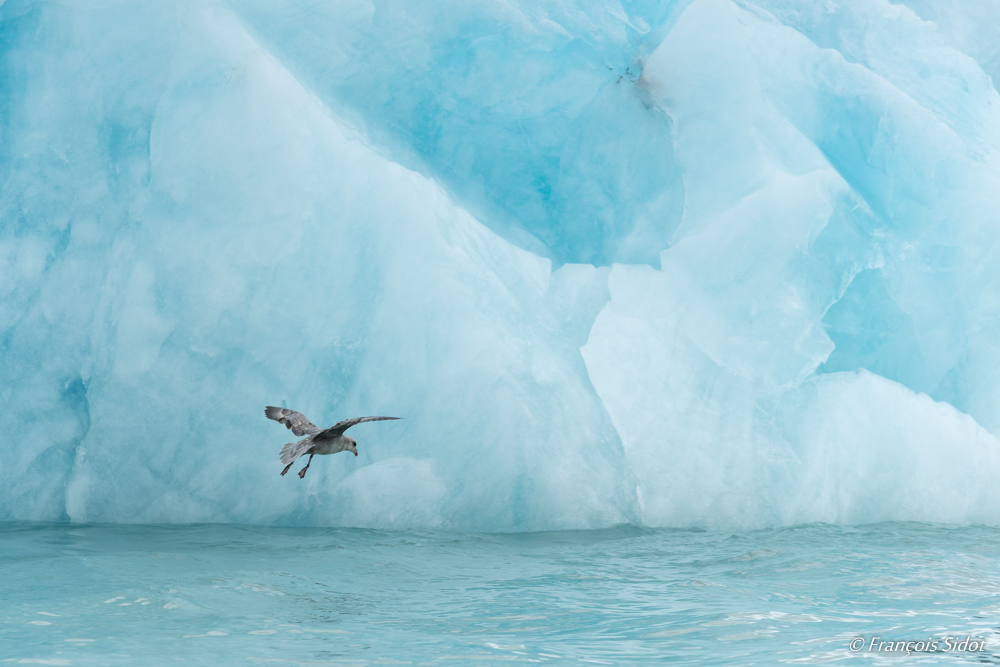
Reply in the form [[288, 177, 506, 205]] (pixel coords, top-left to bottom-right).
[[0, 524, 1000, 665]]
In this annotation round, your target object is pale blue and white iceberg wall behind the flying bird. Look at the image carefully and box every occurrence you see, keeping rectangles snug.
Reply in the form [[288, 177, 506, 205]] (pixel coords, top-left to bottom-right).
[[0, 0, 1000, 530]]
